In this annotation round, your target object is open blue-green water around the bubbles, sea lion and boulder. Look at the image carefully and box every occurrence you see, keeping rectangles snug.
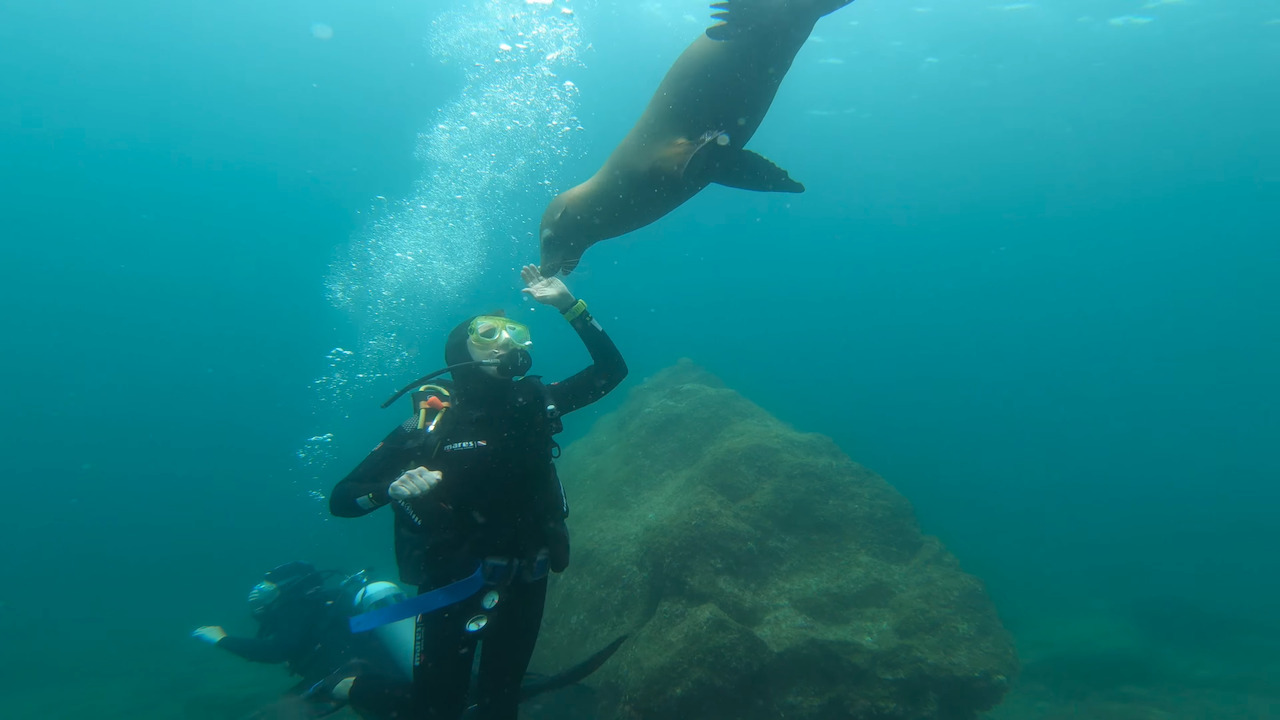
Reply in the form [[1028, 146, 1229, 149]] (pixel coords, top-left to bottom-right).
[[0, 0, 1280, 717]]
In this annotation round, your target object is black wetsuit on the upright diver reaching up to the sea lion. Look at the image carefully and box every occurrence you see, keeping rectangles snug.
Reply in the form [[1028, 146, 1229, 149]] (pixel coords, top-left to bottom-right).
[[329, 307, 627, 720]]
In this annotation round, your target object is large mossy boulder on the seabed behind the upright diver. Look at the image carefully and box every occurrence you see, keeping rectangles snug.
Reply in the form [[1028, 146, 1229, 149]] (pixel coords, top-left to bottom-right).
[[535, 361, 1018, 720]]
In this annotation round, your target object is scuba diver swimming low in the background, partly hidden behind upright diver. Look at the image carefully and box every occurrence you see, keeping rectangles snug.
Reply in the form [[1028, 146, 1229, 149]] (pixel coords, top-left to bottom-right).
[[191, 561, 626, 719]]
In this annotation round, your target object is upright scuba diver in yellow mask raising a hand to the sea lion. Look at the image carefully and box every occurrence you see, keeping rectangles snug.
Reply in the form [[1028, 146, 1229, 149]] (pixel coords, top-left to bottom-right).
[[326, 265, 627, 720]]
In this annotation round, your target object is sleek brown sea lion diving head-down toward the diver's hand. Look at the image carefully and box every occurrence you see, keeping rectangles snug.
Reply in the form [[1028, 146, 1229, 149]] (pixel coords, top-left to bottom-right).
[[540, 0, 852, 277]]
